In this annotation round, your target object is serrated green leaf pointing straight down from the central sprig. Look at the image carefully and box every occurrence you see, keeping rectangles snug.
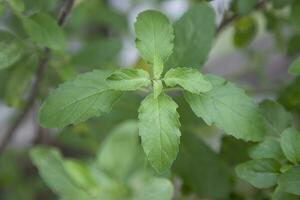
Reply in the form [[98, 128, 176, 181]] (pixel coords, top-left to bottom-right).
[[138, 93, 181, 173]]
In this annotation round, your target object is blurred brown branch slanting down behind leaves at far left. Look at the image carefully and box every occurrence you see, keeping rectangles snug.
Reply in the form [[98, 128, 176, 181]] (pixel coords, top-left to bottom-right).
[[0, 0, 75, 153]]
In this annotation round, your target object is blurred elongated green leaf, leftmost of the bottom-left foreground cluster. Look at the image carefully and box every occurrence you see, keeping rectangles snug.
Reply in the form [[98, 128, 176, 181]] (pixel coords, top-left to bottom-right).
[[30, 147, 89, 200]]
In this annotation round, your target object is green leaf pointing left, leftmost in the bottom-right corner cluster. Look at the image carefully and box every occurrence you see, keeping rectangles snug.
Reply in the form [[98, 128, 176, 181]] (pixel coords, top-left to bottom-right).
[[235, 159, 280, 188]]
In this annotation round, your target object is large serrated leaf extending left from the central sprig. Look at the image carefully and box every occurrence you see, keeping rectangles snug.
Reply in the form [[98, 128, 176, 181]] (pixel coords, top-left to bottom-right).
[[39, 70, 122, 127]]
